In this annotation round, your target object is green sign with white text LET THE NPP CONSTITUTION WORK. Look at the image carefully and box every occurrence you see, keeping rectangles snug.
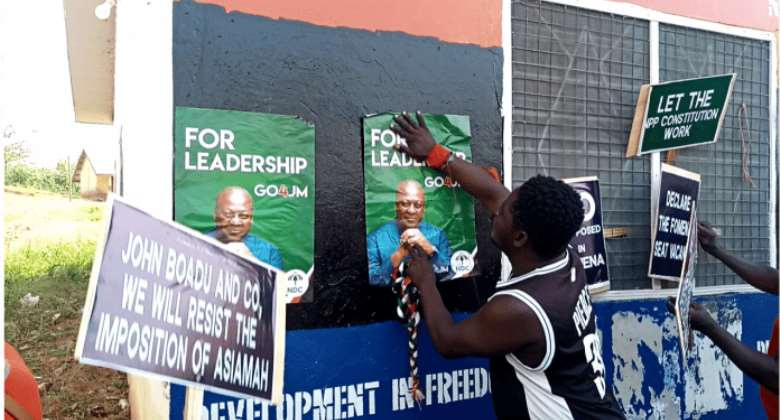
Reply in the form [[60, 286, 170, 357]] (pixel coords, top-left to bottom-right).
[[627, 74, 736, 156]]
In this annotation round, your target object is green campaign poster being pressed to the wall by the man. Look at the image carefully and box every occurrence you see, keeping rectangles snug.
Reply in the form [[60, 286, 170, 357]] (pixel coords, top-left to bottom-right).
[[363, 113, 477, 286]]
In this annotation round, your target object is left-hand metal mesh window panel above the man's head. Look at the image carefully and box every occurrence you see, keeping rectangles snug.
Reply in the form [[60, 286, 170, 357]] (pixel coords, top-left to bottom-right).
[[511, 0, 651, 289]]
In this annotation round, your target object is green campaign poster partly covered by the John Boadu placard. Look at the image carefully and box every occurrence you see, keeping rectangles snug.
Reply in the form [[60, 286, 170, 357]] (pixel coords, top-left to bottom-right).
[[174, 107, 314, 303]]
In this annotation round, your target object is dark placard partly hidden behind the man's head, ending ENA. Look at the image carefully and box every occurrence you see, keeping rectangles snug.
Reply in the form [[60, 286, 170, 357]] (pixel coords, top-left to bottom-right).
[[563, 176, 609, 293]]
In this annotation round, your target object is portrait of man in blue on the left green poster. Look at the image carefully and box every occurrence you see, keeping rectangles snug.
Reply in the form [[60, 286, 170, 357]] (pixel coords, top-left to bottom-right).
[[206, 187, 284, 270]]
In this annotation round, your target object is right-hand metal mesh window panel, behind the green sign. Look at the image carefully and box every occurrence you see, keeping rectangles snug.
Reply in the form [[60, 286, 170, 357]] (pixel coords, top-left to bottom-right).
[[659, 24, 771, 286]]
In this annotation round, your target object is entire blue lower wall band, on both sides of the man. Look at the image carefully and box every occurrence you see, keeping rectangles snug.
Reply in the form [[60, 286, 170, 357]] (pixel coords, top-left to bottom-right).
[[171, 293, 777, 420]]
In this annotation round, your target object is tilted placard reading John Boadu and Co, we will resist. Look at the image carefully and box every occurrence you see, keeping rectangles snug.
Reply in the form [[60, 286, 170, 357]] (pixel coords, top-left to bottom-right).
[[76, 196, 286, 403]]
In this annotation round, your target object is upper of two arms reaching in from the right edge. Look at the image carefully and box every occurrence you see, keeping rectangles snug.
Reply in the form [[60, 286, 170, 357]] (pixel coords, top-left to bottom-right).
[[699, 223, 779, 295]]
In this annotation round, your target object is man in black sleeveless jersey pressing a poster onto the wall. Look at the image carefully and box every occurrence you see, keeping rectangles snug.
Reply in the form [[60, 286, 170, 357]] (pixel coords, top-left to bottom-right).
[[391, 113, 624, 420]]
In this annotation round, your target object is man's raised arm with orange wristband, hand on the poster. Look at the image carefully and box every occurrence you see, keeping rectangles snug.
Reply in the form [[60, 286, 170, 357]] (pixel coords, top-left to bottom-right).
[[390, 111, 509, 213]]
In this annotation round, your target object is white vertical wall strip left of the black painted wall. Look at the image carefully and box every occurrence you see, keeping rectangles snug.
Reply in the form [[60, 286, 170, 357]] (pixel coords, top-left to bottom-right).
[[114, 0, 173, 419]]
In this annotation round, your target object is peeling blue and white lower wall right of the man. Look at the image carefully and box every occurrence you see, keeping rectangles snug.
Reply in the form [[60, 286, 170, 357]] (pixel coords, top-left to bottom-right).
[[596, 293, 777, 419]]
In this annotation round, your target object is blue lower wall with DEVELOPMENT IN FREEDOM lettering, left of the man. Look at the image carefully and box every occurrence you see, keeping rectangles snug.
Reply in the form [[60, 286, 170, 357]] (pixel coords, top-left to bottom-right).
[[171, 317, 492, 419]]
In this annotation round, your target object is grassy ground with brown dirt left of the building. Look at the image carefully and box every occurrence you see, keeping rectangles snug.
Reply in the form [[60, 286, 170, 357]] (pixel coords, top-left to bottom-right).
[[4, 186, 130, 420]]
